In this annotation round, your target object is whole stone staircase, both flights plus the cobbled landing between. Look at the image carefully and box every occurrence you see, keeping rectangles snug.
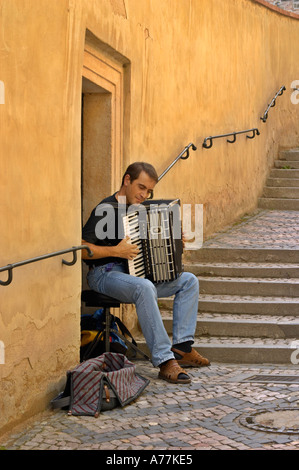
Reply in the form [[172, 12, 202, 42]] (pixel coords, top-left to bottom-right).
[[136, 149, 299, 365]]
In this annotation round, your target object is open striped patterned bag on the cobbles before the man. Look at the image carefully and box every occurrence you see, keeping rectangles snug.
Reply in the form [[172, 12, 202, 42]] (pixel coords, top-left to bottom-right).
[[51, 352, 149, 417]]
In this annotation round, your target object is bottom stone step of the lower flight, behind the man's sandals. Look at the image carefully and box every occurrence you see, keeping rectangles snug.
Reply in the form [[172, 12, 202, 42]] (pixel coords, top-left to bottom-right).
[[136, 337, 298, 366]]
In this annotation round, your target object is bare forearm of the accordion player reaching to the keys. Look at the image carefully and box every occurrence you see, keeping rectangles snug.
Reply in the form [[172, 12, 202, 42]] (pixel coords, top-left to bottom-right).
[[82, 237, 139, 260]]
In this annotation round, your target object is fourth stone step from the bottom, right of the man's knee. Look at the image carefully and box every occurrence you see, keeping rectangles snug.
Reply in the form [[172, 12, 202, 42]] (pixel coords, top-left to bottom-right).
[[198, 276, 299, 300]]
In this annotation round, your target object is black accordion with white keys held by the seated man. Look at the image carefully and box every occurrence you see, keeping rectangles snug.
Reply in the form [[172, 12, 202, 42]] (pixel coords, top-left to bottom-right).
[[123, 199, 183, 283]]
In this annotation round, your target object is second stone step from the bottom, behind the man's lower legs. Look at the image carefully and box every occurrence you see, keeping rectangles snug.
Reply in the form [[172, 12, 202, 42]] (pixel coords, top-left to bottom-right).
[[161, 311, 299, 338]]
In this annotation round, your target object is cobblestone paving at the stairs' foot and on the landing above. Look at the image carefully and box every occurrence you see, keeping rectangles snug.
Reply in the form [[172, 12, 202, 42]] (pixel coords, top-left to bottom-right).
[[0, 211, 299, 452]]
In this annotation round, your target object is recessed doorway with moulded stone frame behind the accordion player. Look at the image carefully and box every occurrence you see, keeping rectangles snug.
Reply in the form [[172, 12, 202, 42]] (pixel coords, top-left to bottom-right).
[[81, 32, 127, 298]]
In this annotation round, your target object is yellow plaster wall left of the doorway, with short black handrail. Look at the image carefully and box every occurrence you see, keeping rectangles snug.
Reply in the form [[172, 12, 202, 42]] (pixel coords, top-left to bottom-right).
[[0, 0, 82, 430]]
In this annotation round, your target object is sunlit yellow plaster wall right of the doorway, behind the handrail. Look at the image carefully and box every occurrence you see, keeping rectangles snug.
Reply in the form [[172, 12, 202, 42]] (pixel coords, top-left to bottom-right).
[[83, 0, 299, 237]]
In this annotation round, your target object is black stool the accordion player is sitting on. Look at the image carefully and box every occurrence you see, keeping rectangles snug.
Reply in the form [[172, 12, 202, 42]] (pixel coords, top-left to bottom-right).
[[81, 290, 149, 360]]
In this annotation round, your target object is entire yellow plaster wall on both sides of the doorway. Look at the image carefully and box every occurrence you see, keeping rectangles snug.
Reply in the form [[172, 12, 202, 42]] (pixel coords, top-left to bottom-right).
[[0, 0, 299, 431]]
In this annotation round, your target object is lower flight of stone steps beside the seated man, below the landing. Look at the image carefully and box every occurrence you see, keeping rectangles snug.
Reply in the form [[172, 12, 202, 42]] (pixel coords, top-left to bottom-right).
[[178, 248, 299, 364]]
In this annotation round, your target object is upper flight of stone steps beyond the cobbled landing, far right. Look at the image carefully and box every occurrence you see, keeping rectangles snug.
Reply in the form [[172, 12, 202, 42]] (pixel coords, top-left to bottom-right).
[[259, 148, 299, 211]]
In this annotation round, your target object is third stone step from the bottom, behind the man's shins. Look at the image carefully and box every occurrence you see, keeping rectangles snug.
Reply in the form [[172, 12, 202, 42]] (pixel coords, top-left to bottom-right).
[[159, 294, 299, 317]]
